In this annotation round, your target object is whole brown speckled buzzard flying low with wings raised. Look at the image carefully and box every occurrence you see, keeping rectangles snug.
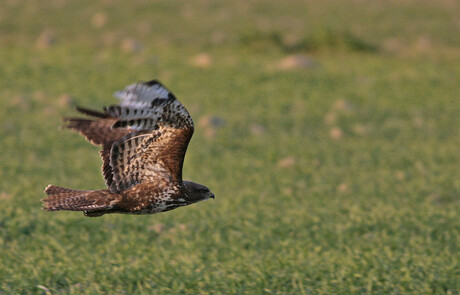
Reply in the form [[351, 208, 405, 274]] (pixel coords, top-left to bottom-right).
[[42, 80, 214, 217]]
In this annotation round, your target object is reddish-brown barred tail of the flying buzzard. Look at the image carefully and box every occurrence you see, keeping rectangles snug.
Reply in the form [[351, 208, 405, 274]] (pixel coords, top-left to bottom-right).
[[42, 185, 120, 217]]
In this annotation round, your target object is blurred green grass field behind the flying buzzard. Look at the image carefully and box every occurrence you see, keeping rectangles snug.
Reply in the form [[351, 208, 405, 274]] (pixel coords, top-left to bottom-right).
[[0, 0, 460, 294]]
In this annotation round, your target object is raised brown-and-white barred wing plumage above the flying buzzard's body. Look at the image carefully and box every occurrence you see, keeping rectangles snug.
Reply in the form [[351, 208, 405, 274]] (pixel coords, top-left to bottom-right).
[[67, 80, 194, 192]]
